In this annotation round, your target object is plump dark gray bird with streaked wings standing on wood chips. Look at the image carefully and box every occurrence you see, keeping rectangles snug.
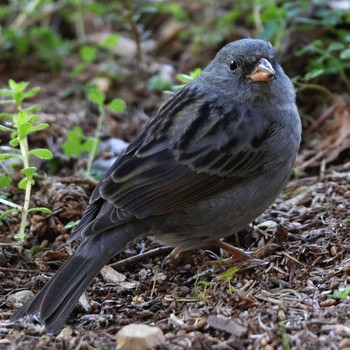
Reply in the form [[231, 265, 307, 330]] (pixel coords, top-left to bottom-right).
[[12, 39, 301, 333]]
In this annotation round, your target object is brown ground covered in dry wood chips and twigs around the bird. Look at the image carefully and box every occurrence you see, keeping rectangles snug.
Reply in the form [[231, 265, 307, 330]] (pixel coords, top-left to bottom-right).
[[0, 30, 350, 350]]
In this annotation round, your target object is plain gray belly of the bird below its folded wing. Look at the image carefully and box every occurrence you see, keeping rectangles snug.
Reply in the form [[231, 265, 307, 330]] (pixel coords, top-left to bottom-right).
[[152, 168, 289, 249]]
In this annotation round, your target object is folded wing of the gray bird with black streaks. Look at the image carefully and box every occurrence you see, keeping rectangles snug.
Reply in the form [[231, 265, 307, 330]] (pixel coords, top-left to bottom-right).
[[76, 86, 275, 236]]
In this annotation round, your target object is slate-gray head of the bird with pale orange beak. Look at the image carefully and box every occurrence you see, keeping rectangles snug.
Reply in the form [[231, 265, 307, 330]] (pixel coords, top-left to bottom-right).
[[197, 39, 295, 104]]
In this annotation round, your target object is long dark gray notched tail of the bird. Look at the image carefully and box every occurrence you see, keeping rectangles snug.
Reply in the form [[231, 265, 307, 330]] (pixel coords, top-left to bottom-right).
[[11, 226, 139, 334]]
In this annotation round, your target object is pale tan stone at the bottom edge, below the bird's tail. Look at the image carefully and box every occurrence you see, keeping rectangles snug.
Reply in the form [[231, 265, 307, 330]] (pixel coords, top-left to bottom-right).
[[117, 323, 165, 350]]
